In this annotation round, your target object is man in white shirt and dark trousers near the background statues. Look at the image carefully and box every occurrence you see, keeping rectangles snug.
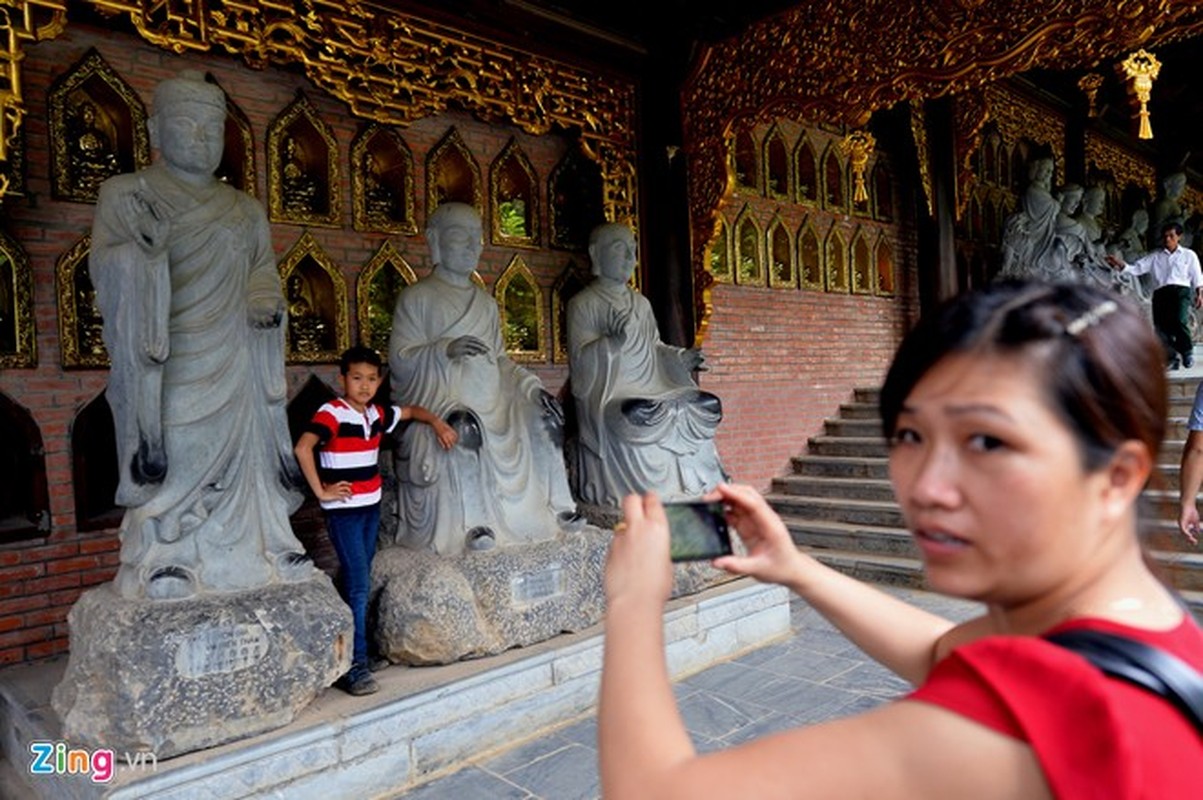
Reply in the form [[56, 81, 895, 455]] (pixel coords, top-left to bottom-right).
[[1107, 221, 1203, 369]]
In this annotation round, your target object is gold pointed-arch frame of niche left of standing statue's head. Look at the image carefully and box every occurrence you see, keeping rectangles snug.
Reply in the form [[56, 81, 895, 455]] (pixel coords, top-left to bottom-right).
[[46, 48, 150, 203]]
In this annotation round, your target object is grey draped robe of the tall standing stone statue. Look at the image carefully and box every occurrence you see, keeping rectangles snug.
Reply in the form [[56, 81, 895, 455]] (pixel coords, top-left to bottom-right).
[[89, 165, 312, 598]]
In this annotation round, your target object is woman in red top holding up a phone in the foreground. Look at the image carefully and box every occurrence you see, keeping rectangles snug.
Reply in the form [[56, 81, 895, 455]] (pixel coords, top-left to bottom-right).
[[598, 277, 1203, 800]]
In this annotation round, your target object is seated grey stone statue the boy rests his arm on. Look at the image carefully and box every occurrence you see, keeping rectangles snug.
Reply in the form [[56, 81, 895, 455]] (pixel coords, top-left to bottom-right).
[[389, 202, 582, 555]]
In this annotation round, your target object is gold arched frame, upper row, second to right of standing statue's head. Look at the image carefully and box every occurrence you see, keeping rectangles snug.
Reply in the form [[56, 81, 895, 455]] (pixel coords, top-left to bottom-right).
[[267, 90, 343, 227]]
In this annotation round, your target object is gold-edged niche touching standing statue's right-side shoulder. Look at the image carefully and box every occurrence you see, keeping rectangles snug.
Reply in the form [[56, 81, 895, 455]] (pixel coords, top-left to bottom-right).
[[279, 231, 350, 363]]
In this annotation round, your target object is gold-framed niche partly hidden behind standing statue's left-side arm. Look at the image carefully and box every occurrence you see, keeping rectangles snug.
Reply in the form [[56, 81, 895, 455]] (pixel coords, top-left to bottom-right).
[[54, 233, 109, 369]]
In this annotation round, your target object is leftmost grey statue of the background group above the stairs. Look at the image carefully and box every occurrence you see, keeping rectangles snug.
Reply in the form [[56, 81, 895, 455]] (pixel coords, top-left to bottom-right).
[[998, 158, 1061, 278]]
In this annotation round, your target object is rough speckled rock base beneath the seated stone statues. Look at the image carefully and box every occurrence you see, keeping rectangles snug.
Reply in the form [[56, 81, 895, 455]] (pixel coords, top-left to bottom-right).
[[372, 526, 731, 665]]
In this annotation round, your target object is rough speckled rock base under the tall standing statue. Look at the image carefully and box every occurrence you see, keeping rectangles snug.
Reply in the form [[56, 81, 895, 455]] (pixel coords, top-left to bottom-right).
[[52, 575, 352, 759]]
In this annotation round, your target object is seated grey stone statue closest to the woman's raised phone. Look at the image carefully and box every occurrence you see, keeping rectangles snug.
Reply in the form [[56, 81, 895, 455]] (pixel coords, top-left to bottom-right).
[[568, 223, 724, 506]]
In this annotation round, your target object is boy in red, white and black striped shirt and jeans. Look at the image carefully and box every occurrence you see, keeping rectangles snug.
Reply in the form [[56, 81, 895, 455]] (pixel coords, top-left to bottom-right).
[[294, 345, 456, 695]]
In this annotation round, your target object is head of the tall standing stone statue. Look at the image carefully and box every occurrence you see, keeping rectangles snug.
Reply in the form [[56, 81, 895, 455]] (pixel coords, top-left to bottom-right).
[[148, 70, 226, 178]]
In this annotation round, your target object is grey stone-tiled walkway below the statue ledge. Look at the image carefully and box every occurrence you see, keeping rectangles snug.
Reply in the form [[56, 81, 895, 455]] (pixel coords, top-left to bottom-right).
[[390, 589, 979, 800]]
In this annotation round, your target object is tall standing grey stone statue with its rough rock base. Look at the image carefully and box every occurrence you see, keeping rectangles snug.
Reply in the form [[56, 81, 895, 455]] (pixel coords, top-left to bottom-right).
[[52, 71, 352, 759]]
